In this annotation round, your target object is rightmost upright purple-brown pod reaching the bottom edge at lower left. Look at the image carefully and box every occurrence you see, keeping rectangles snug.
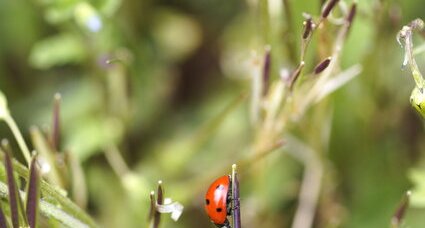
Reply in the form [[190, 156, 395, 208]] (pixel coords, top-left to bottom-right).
[[26, 156, 40, 228]]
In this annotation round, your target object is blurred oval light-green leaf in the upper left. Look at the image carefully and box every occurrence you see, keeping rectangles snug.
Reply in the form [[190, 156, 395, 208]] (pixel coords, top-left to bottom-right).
[[29, 34, 87, 69]]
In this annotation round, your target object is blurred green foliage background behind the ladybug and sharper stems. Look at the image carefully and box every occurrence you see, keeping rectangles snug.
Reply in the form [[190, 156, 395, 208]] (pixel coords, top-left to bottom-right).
[[0, 0, 425, 228]]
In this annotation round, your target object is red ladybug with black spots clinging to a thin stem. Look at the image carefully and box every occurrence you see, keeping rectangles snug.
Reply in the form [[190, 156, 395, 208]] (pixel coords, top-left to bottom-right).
[[205, 175, 232, 228]]
